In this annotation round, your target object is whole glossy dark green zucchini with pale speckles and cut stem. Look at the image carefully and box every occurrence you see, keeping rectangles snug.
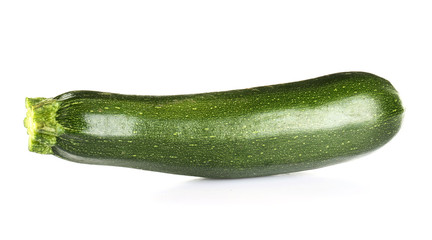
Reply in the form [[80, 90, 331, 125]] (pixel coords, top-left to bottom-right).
[[24, 72, 403, 178]]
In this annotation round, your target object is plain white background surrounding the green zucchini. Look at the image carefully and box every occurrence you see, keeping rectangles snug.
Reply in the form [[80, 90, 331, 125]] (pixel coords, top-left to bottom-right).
[[0, 0, 432, 239]]
